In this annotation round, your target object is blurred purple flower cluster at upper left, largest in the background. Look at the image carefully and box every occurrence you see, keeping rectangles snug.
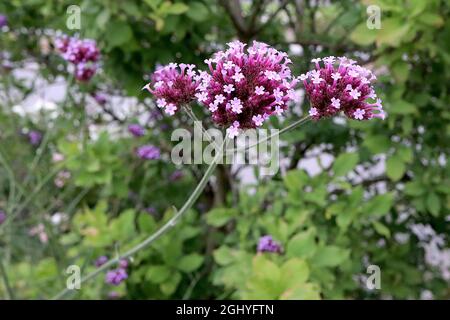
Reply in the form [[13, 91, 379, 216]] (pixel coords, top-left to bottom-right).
[[55, 36, 100, 81]]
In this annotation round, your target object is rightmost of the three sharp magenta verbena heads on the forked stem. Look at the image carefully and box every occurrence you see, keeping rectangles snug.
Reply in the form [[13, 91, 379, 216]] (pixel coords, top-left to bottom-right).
[[299, 56, 386, 120]]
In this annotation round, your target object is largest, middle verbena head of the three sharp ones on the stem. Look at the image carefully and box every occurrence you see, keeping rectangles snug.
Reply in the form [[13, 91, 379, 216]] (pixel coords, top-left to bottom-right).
[[196, 41, 297, 137]]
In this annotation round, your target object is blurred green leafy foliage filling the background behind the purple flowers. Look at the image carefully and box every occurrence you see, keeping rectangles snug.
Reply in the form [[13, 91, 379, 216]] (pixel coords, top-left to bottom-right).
[[0, 0, 450, 299]]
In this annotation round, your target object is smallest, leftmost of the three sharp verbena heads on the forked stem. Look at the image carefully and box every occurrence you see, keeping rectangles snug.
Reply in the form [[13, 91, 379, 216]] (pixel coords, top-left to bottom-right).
[[143, 63, 198, 116]]
